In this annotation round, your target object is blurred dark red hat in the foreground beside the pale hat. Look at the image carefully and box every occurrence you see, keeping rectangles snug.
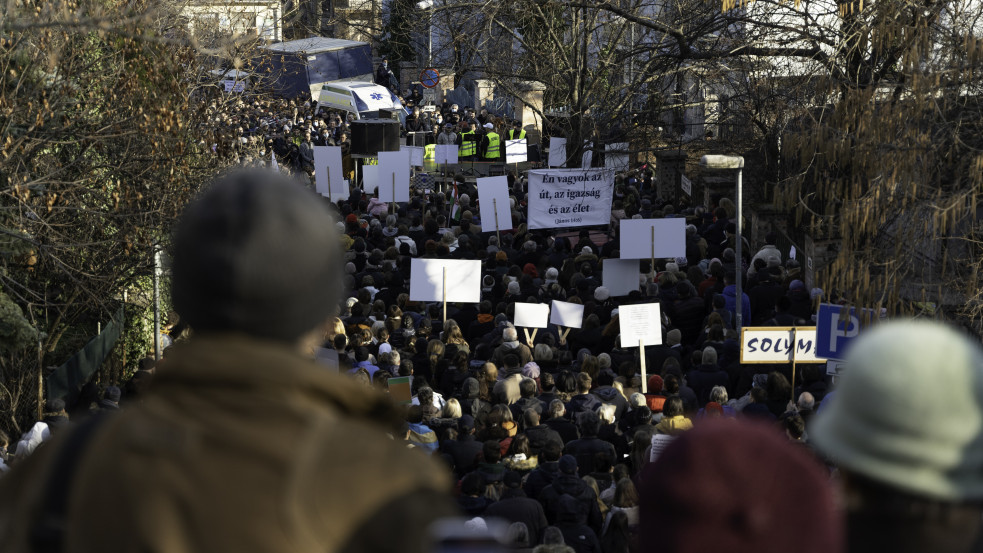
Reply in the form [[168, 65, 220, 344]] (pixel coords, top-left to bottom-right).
[[638, 419, 843, 553]]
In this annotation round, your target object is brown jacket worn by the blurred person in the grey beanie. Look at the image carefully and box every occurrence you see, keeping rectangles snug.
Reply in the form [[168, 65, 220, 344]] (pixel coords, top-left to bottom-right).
[[0, 336, 453, 553]]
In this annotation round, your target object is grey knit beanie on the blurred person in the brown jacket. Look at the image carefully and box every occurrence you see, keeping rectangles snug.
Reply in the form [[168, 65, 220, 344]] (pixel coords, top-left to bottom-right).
[[172, 170, 343, 342]]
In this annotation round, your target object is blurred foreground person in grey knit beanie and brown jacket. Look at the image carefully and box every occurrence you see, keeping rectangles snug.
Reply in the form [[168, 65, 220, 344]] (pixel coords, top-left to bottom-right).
[[0, 172, 454, 553]]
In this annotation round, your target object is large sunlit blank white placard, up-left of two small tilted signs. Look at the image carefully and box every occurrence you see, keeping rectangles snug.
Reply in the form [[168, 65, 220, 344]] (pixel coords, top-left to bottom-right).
[[410, 259, 481, 303]]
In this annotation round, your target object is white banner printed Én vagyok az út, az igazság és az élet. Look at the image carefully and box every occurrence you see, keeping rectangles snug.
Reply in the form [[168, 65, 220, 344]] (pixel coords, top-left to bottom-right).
[[528, 169, 616, 229]]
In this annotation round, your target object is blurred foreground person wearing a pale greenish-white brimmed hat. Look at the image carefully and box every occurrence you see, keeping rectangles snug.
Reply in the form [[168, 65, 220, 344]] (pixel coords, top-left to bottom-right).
[[809, 321, 983, 553]]
